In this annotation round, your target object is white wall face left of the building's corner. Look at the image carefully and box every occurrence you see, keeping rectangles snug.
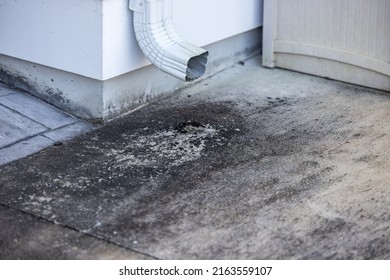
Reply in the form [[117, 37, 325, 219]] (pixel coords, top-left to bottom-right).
[[0, 0, 102, 77]]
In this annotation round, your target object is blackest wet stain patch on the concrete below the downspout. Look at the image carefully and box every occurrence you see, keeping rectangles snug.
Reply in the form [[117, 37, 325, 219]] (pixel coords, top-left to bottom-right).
[[1, 101, 242, 229]]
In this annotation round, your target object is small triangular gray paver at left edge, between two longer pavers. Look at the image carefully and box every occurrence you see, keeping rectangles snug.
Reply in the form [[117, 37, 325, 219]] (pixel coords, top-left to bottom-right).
[[0, 104, 47, 148]]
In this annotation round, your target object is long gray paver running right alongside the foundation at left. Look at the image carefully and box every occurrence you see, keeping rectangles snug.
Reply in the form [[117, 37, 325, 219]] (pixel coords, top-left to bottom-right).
[[0, 93, 77, 129]]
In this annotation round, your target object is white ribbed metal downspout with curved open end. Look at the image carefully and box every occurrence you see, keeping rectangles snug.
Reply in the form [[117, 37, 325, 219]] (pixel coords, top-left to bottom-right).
[[130, 0, 209, 81]]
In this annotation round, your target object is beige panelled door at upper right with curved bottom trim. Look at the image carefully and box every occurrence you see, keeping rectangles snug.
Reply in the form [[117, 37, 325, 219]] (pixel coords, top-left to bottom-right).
[[263, 0, 390, 91]]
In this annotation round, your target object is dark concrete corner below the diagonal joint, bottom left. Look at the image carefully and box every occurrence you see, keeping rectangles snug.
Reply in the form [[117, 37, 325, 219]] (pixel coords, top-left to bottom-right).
[[0, 205, 150, 260]]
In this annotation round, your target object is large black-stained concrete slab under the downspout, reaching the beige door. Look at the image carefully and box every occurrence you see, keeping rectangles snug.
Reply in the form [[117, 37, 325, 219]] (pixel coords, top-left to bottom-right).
[[0, 57, 390, 259]]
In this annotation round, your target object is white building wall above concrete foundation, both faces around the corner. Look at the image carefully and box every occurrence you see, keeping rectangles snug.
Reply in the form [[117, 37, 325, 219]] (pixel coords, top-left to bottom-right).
[[0, 0, 262, 80]]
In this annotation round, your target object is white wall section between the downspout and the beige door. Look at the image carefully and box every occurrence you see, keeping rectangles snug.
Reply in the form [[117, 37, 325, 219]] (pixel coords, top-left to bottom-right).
[[173, 0, 263, 46]]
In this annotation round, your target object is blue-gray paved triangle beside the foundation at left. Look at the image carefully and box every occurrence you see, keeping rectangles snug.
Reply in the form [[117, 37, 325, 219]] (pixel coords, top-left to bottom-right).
[[0, 83, 94, 165]]
